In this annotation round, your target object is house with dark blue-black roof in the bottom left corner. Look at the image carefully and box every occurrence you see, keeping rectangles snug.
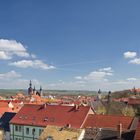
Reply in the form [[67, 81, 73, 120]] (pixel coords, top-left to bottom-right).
[[0, 112, 16, 140]]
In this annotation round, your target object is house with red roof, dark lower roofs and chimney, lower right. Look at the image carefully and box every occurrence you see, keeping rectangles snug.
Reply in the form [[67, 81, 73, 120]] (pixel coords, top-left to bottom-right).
[[83, 114, 138, 140]]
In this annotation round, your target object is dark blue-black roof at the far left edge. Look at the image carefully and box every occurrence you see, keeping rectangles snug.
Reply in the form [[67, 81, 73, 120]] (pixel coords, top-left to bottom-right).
[[0, 112, 16, 131]]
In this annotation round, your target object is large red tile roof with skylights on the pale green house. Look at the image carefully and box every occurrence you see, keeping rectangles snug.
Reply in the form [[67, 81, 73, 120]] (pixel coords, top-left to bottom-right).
[[11, 105, 90, 128]]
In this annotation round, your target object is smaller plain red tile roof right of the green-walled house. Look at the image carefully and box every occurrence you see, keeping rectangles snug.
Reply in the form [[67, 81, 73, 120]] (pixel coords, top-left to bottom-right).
[[84, 115, 133, 130]]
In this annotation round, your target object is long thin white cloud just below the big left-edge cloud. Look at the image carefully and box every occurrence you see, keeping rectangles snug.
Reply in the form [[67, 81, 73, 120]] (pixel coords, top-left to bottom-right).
[[9, 60, 55, 70]]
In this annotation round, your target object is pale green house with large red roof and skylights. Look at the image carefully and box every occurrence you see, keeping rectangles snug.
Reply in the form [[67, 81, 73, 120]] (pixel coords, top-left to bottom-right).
[[10, 104, 93, 140]]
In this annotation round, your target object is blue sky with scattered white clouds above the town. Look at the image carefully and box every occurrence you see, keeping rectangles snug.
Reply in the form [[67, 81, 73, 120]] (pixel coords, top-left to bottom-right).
[[0, 0, 140, 91]]
